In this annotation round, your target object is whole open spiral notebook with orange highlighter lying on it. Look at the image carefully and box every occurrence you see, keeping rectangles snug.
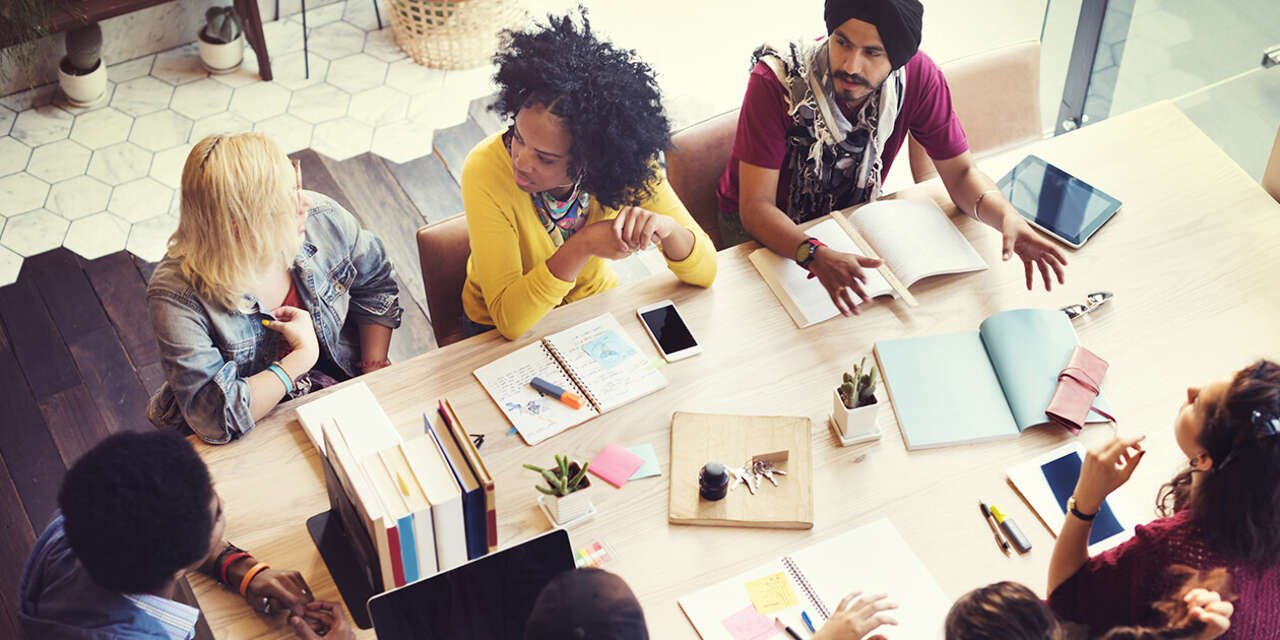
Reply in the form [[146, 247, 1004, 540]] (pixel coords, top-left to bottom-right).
[[475, 314, 667, 444]]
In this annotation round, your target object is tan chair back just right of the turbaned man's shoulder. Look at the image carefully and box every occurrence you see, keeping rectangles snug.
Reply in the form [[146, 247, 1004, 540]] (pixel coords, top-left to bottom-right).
[[908, 40, 1043, 182]]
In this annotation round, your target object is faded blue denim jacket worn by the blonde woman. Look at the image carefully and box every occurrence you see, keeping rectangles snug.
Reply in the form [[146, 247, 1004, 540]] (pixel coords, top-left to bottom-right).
[[147, 192, 402, 444]]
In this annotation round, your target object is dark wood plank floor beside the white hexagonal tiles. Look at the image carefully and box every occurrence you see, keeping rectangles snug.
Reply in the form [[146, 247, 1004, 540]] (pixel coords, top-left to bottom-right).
[[0, 99, 500, 637]]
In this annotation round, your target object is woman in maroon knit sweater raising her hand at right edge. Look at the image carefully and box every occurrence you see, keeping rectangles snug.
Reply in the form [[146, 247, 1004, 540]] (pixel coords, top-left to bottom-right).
[[1048, 360, 1280, 640]]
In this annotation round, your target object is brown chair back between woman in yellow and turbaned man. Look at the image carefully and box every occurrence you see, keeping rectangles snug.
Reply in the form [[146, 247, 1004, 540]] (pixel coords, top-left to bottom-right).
[[666, 109, 739, 248]]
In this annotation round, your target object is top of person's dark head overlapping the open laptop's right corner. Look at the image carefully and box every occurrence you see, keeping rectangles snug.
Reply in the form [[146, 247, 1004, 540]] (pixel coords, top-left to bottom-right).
[[525, 568, 649, 640]]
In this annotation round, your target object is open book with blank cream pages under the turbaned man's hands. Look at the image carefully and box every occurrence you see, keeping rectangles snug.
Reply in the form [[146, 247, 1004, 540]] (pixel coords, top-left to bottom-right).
[[748, 200, 987, 329]]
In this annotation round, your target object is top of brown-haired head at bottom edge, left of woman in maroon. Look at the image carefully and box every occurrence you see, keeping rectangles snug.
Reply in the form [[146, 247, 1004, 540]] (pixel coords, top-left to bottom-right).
[[943, 581, 1060, 640]]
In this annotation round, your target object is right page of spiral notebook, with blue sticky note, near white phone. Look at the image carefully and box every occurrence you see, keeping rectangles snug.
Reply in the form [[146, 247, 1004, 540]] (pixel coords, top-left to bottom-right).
[[544, 314, 667, 413]]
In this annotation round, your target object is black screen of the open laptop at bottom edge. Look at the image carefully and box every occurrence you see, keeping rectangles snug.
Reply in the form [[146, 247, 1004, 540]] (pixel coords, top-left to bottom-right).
[[369, 529, 573, 640]]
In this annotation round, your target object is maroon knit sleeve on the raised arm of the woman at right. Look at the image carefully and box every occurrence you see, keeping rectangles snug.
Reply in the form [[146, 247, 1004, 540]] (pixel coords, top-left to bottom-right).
[[1048, 513, 1187, 634]]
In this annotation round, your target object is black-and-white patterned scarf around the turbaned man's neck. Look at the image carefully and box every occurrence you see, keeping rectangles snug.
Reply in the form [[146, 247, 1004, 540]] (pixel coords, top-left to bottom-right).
[[751, 38, 906, 223]]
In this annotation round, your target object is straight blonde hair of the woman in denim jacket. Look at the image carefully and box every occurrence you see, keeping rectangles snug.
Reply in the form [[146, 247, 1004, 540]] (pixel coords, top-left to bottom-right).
[[169, 133, 300, 310]]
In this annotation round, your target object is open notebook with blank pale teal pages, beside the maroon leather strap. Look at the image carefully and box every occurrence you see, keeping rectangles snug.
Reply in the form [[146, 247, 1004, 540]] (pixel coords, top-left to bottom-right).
[[876, 308, 1107, 449]]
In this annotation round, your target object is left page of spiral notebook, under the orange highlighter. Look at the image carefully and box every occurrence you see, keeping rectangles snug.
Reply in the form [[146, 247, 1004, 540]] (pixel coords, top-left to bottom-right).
[[475, 342, 599, 444]]
